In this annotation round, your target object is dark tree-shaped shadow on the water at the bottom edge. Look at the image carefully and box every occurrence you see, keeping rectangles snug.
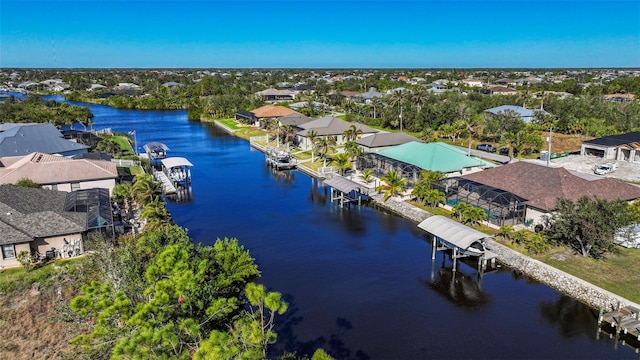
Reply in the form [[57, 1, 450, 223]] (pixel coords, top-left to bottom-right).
[[269, 294, 370, 360]]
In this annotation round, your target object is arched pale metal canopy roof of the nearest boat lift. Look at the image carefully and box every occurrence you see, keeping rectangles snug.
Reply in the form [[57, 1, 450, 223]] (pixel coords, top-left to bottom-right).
[[418, 215, 491, 255]]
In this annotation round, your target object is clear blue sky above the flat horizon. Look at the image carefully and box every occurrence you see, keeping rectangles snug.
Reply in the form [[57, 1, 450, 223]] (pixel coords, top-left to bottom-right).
[[0, 0, 640, 68]]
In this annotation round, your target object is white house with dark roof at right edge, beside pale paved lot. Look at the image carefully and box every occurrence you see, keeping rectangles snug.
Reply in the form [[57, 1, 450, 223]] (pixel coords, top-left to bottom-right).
[[580, 132, 640, 162]]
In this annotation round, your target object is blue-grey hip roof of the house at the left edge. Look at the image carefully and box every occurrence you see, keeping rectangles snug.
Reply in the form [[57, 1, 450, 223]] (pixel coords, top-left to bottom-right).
[[0, 123, 89, 157]]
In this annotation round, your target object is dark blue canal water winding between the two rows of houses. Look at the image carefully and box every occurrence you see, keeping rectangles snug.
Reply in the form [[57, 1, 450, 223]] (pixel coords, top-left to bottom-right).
[[40, 98, 638, 359]]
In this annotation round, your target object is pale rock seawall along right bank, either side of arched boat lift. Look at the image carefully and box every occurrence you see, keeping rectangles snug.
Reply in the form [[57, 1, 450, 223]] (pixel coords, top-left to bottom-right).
[[371, 194, 640, 311]]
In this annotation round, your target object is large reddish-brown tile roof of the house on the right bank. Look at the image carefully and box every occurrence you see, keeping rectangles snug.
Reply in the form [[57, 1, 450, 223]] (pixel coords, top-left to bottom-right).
[[462, 161, 640, 211]]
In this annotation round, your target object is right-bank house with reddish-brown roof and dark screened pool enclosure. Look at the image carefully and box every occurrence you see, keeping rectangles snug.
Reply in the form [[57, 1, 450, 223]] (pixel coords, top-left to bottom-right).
[[441, 161, 640, 227]]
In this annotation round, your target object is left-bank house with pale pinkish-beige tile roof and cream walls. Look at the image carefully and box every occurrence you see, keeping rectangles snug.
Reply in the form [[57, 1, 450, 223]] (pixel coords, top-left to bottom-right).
[[0, 152, 118, 194]]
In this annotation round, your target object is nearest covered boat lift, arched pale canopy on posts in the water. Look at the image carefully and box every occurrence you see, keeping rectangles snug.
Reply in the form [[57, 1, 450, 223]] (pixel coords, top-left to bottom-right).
[[418, 215, 497, 271]]
